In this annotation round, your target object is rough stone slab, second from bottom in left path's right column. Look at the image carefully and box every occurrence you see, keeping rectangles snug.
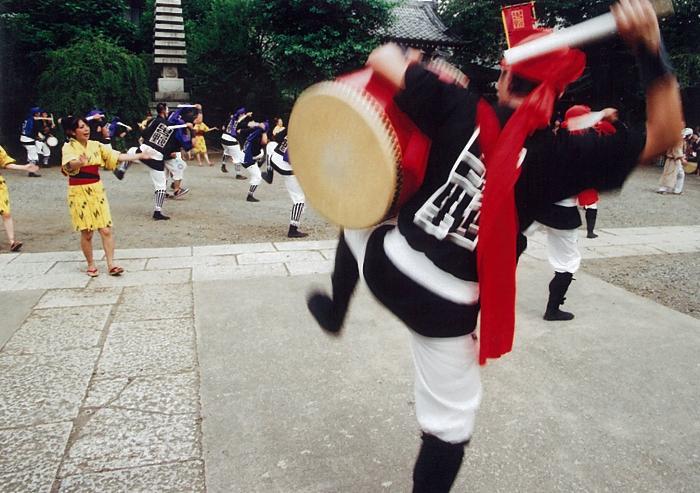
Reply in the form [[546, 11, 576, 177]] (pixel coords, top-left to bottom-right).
[[59, 408, 201, 478]]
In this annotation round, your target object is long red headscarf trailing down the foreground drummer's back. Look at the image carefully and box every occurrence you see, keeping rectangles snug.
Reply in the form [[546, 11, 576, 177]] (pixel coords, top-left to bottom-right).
[[477, 31, 586, 365]]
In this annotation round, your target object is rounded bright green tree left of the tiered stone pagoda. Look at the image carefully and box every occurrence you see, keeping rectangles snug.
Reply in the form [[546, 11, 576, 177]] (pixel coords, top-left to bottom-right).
[[39, 37, 149, 122]]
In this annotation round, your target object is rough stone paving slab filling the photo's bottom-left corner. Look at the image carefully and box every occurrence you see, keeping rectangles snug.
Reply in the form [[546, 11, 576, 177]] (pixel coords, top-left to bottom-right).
[[0, 421, 73, 493]]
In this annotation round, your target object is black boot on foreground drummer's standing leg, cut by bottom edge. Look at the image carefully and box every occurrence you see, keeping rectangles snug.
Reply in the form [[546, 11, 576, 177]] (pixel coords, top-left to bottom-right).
[[413, 433, 469, 493]]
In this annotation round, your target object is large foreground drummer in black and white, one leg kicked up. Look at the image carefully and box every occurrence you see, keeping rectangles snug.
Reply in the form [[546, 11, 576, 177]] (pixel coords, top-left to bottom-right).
[[308, 0, 682, 492]]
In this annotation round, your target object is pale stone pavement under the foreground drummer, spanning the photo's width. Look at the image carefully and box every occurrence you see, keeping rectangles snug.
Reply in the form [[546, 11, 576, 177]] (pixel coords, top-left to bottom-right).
[[0, 226, 700, 492]]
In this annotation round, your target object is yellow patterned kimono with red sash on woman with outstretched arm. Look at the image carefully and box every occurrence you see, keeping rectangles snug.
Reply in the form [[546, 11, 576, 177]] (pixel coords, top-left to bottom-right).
[[62, 139, 119, 231]]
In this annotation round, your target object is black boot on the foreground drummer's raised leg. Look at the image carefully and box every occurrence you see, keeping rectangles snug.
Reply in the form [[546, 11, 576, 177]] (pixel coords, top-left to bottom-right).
[[306, 234, 360, 335]]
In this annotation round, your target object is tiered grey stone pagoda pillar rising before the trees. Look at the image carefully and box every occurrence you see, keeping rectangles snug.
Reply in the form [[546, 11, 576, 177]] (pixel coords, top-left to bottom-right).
[[153, 0, 190, 106]]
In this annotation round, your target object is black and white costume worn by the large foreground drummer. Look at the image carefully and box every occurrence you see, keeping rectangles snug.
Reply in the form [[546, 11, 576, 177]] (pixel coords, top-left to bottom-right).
[[308, 65, 644, 491]]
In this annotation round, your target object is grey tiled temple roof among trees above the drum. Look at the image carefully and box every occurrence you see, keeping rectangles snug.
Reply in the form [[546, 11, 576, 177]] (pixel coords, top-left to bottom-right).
[[384, 0, 462, 47]]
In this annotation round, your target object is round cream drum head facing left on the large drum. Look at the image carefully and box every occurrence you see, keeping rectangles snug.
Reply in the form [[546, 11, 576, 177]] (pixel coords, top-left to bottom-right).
[[287, 81, 401, 228]]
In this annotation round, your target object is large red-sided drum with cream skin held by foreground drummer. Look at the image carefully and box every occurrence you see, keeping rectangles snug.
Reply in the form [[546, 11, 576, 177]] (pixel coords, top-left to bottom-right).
[[287, 68, 430, 228]]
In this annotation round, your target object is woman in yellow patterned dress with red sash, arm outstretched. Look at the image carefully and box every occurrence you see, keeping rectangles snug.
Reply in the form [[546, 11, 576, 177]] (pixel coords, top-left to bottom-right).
[[61, 116, 150, 277]]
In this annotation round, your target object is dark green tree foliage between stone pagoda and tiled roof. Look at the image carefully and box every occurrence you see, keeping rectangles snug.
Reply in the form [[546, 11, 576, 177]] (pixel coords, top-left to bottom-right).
[[187, 0, 389, 122]]
